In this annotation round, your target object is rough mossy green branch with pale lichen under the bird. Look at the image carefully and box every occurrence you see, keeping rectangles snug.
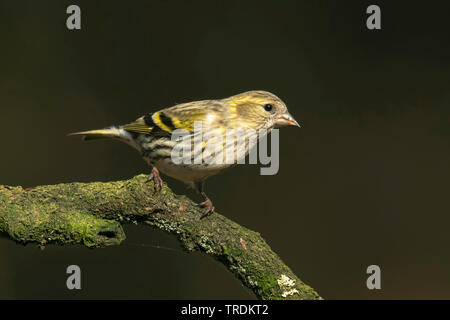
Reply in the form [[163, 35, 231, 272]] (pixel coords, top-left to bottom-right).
[[0, 175, 320, 299]]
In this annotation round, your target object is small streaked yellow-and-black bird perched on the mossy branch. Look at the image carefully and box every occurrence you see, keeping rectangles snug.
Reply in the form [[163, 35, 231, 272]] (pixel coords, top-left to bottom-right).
[[70, 91, 300, 218]]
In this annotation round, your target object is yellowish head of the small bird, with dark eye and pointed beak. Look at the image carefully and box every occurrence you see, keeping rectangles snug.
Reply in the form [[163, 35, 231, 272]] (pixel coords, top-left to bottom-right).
[[224, 91, 300, 130]]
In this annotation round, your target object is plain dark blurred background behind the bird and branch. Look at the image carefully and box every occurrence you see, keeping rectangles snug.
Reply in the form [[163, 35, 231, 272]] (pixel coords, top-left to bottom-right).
[[0, 0, 450, 299]]
